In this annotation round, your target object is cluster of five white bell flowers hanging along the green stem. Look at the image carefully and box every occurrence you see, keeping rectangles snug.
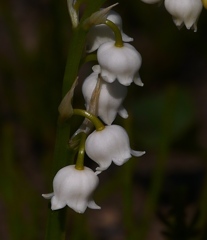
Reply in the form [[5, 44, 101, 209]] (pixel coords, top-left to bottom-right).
[[43, 7, 145, 213]]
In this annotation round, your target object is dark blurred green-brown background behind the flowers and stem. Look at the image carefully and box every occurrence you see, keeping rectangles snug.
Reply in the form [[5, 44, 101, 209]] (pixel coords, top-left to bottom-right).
[[0, 0, 207, 240]]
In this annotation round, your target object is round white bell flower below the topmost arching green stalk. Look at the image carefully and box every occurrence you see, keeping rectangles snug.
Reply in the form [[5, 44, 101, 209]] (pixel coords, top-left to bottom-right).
[[97, 42, 143, 86]]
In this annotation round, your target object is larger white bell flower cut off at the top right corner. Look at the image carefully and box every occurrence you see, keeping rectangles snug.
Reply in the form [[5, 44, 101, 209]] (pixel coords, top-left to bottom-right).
[[165, 0, 203, 32]]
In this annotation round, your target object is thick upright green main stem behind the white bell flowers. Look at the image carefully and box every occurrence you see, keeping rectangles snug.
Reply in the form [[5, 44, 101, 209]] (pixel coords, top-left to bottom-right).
[[45, 0, 104, 240]]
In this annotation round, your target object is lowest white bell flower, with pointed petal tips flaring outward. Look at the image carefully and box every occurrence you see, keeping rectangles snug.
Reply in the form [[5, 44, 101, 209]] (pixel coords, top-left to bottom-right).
[[42, 165, 100, 213]]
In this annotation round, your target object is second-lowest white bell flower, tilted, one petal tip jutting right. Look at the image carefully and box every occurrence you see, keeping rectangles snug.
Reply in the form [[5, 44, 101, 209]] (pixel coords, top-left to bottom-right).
[[85, 125, 145, 174]]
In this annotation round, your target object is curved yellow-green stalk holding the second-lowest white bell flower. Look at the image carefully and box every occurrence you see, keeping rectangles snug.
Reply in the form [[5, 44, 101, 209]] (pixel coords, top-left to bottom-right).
[[73, 109, 105, 131]]
